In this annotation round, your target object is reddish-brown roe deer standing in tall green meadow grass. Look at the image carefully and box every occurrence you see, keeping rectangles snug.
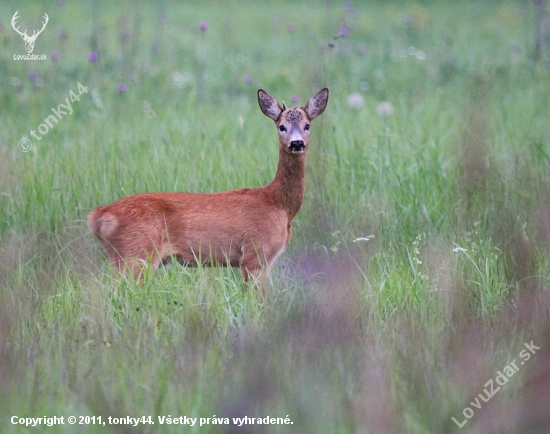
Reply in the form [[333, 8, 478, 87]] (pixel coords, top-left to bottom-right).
[[88, 88, 328, 283]]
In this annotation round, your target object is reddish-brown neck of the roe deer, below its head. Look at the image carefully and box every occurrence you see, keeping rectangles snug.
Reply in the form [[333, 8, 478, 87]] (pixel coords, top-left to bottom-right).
[[267, 149, 307, 220]]
